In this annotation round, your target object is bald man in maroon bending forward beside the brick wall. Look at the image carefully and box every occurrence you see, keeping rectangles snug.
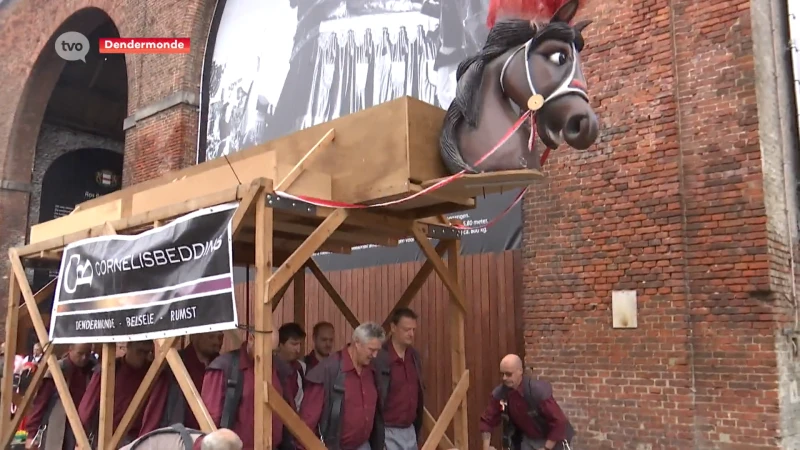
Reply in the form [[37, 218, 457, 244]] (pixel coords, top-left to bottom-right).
[[480, 355, 575, 450]]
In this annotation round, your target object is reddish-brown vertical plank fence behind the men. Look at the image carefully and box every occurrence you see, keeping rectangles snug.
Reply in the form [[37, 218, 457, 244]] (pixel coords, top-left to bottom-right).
[[225, 250, 524, 450]]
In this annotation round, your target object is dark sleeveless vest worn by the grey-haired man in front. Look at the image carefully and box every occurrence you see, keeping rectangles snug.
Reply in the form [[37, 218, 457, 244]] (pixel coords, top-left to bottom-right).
[[306, 351, 386, 450]]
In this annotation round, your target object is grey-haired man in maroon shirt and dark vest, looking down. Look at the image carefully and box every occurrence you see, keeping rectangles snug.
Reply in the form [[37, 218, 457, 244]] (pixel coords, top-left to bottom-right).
[[300, 322, 386, 450]]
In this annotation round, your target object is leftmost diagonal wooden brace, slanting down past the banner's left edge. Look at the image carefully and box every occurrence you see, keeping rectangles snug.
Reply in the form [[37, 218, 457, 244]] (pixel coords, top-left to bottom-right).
[[8, 248, 91, 448]]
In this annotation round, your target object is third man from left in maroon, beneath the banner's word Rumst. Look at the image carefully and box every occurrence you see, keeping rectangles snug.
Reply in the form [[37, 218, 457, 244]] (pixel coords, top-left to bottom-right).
[[138, 331, 224, 436]]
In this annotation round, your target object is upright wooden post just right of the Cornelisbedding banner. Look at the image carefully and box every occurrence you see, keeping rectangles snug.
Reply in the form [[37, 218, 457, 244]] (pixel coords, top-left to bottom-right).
[[256, 186, 282, 449]]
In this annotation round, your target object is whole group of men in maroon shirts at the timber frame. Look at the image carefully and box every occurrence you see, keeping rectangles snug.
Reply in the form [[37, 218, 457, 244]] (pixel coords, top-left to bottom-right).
[[15, 308, 572, 450]]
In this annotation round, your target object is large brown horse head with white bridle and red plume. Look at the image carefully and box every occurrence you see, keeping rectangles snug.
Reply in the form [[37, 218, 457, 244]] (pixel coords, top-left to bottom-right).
[[440, 0, 598, 173]]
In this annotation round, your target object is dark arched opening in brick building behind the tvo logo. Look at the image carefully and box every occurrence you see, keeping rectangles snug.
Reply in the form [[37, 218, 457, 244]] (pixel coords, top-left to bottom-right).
[[5, 8, 128, 352]]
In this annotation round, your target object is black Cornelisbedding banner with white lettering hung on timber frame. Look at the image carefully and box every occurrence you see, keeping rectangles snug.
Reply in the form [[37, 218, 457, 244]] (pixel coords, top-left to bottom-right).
[[50, 203, 238, 344]]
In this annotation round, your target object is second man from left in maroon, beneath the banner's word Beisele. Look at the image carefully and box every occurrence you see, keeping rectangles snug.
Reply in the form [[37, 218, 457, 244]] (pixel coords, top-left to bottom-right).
[[78, 341, 153, 445]]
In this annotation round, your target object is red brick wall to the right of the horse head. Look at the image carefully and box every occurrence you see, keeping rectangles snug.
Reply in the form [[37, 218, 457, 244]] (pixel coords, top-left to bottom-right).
[[524, 0, 779, 449]]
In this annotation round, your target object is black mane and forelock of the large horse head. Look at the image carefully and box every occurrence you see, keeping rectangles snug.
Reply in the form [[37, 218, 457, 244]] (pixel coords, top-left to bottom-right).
[[440, 19, 583, 173]]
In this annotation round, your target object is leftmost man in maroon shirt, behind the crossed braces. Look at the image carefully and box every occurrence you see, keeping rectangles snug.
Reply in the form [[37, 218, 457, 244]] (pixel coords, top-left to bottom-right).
[[25, 344, 93, 450]]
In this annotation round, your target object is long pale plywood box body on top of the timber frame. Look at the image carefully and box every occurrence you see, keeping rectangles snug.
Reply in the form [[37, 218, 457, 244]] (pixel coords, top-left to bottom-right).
[[30, 97, 541, 250]]
